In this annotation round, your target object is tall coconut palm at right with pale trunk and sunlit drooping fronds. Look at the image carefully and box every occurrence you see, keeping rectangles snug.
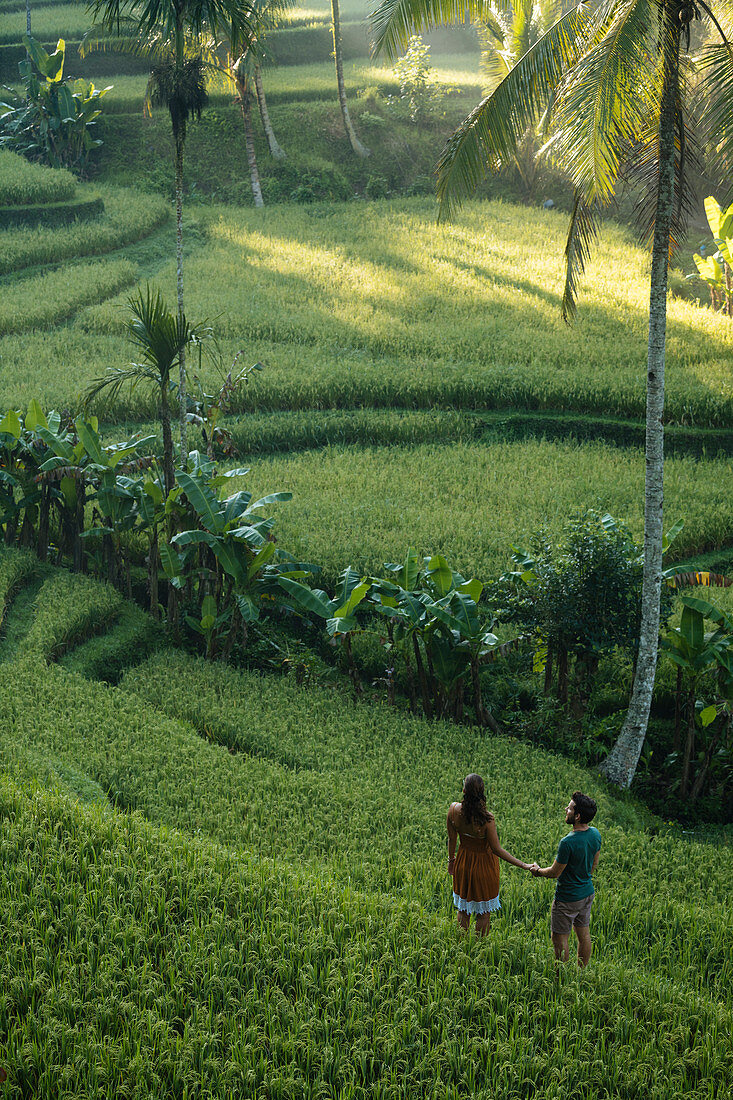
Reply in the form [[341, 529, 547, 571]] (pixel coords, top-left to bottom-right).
[[372, 0, 733, 787]]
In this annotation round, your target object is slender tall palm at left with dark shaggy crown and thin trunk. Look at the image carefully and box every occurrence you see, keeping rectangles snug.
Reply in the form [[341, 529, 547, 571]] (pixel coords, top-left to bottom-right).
[[83, 0, 256, 469]]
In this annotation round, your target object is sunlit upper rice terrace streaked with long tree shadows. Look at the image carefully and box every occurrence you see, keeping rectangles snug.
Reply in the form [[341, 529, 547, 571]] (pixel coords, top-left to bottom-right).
[[72, 199, 733, 426]]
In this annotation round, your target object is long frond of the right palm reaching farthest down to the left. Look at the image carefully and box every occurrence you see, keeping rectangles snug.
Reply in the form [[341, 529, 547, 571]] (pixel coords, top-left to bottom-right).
[[437, 3, 593, 220]]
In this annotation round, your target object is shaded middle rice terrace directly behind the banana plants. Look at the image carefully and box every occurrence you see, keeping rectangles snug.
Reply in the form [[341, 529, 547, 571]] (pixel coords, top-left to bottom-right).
[[230, 440, 733, 582]]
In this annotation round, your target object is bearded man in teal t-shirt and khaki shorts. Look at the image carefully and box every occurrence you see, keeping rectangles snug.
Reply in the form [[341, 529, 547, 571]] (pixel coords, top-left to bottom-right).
[[529, 791, 601, 967]]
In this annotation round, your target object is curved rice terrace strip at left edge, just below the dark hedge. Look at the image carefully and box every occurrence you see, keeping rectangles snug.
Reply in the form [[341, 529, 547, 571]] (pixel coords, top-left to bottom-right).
[[0, 184, 169, 275]]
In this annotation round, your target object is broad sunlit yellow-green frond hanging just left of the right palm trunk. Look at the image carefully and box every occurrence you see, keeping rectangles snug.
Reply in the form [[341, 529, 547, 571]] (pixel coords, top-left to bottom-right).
[[546, 0, 660, 202]]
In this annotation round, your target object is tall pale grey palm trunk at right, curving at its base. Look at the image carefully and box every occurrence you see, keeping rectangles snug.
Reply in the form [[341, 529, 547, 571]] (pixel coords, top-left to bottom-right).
[[601, 0, 680, 788]]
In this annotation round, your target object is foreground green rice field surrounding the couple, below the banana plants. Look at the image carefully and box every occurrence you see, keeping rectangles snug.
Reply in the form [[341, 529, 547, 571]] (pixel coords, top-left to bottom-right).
[[0, 551, 733, 1100]]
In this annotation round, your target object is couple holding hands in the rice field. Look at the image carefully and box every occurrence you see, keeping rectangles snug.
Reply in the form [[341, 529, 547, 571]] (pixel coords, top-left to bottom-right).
[[448, 773, 601, 966]]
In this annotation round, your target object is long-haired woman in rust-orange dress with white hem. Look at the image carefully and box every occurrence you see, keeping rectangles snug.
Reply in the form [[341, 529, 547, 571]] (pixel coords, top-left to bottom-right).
[[448, 773, 530, 936]]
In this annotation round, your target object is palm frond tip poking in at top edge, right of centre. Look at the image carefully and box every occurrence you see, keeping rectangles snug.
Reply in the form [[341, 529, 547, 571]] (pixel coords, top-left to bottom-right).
[[369, 0, 497, 58]]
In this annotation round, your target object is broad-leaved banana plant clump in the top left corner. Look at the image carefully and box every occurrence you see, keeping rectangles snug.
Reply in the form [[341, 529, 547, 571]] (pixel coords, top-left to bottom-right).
[[0, 35, 107, 168]]
